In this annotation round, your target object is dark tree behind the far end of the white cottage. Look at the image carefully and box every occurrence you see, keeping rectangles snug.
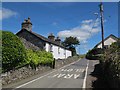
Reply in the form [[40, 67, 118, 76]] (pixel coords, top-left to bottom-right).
[[63, 36, 80, 56]]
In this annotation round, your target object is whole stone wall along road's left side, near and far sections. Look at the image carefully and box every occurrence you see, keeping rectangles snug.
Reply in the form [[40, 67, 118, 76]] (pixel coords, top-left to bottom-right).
[[1, 56, 79, 85]]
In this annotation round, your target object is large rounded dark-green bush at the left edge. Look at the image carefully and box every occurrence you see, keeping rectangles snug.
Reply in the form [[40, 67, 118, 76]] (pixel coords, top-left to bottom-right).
[[2, 31, 27, 71]]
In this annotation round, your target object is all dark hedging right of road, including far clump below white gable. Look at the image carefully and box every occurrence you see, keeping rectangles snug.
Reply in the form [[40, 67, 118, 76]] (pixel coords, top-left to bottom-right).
[[86, 39, 120, 88]]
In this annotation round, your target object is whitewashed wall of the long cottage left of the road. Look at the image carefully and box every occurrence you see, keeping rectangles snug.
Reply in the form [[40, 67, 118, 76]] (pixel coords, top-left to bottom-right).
[[45, 43, 72, 59]]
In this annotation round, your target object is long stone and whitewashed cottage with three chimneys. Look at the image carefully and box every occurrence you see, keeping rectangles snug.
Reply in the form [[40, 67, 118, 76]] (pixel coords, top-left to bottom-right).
[[16, 18, 72, 59]]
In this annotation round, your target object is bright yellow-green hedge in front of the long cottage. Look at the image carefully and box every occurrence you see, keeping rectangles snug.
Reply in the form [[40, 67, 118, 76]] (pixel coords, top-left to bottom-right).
[[26, 49, 53, 68]]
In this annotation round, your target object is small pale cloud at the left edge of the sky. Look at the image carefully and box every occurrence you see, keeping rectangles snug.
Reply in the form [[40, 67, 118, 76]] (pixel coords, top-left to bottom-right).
[[0, 8, 18, 20]]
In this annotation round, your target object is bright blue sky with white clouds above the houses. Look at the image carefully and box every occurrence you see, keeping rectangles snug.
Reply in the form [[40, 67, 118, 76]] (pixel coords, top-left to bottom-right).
[[0, 2, 118, 54]]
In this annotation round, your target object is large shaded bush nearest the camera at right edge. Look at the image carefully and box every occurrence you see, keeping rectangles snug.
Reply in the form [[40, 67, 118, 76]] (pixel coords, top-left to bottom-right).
[[101, 39, 120, 88]]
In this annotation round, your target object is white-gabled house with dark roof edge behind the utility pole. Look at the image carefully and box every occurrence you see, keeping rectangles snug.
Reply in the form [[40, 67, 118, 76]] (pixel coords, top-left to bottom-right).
[[95, 34, 118, 48]]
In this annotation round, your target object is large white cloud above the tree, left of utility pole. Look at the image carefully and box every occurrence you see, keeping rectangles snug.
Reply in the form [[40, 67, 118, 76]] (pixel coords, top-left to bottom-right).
[[58, 19, 100, 43]]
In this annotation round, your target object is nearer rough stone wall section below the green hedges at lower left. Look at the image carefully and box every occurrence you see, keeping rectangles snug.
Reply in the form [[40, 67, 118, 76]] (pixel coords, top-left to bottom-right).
[[1, 66, 52, 85]]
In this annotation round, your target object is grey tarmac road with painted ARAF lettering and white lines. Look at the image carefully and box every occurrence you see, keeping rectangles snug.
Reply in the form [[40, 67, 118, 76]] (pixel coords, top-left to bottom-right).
[[4, 59, 98, 90]]
